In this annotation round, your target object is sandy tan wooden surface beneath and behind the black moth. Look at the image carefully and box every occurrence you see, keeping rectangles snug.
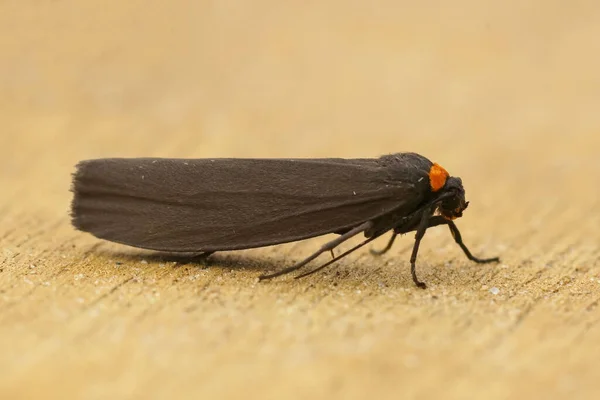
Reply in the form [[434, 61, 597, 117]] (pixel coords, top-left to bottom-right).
[[0, 0, 600, 399]]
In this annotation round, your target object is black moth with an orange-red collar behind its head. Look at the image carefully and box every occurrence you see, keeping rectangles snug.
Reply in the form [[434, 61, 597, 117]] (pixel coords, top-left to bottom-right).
[[72, 153, 498, 288]]
